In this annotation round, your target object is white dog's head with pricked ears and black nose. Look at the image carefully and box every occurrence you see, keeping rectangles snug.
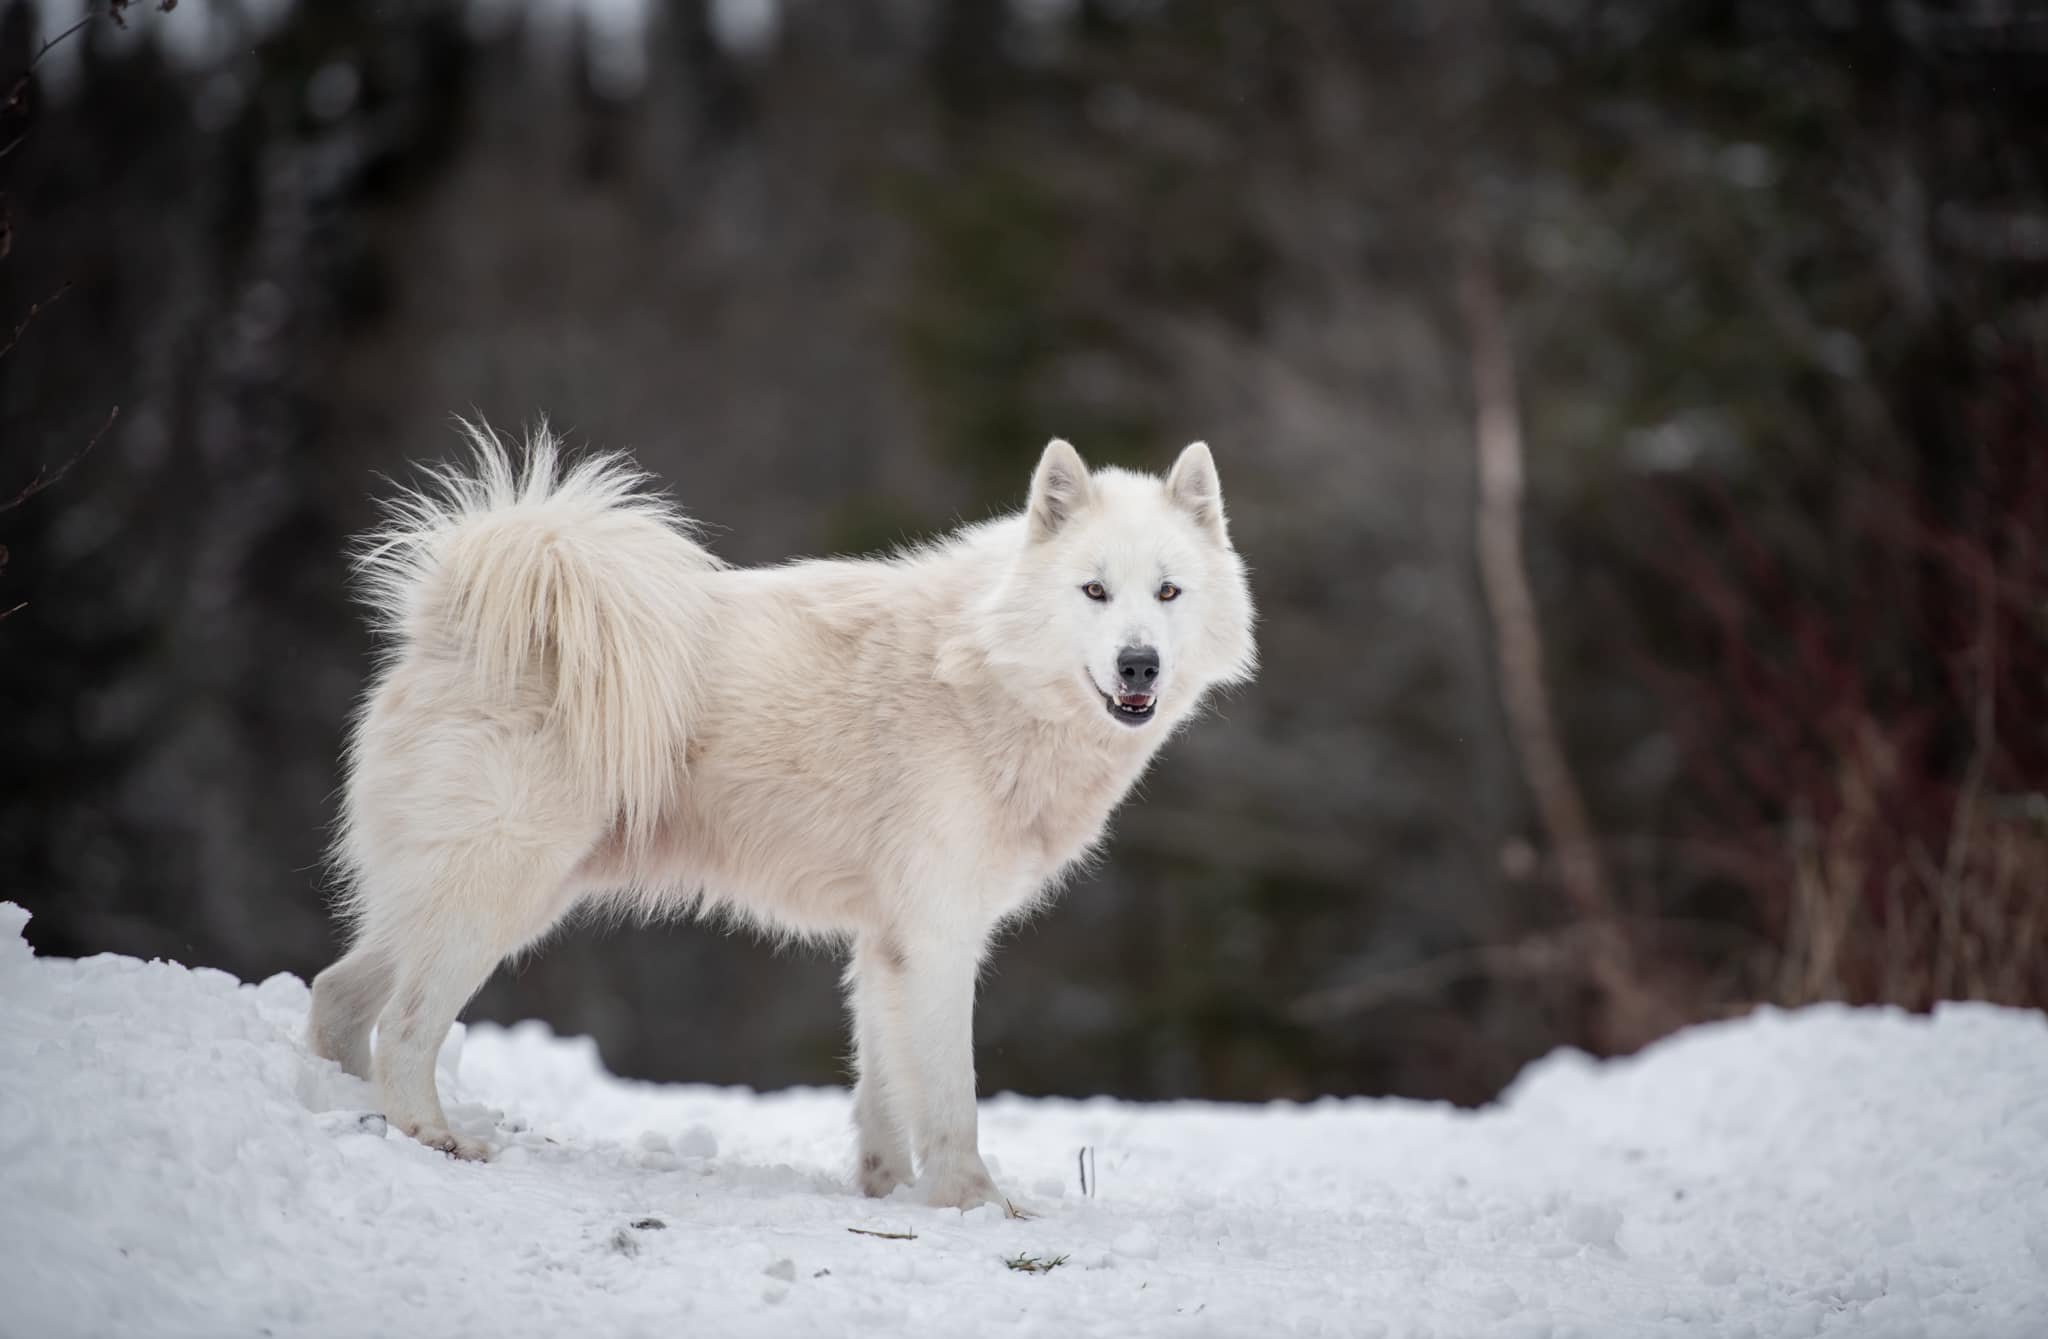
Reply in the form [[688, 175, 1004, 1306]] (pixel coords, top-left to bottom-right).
[[987, 440, 1255, 731]]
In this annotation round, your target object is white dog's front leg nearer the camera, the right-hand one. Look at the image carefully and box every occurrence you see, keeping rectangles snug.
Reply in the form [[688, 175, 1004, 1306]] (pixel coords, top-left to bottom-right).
[[872, 932, 1001, 1208]]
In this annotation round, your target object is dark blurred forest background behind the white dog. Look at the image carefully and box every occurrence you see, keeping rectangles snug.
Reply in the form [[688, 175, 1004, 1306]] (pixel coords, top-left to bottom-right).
[[0, 0, 2048, 1102]]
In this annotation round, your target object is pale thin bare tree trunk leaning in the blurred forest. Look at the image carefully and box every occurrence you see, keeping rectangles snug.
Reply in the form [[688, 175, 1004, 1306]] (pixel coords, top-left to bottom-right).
[[1460, 244, 1681, 1050]]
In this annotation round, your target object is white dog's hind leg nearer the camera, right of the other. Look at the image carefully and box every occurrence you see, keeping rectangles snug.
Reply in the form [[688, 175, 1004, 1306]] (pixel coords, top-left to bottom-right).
[[373, 841, 573, 1159]]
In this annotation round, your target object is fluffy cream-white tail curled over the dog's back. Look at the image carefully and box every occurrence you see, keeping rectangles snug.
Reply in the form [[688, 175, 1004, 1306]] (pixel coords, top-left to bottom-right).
[[356, 422, 719, 837]]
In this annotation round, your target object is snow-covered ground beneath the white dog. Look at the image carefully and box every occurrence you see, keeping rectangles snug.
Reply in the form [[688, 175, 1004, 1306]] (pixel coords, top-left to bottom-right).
[[0, 905, 2048, 1339]]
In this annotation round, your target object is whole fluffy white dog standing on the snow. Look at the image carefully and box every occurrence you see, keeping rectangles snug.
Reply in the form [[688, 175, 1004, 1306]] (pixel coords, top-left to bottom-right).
[[309, 428, 1253, 1208]]
